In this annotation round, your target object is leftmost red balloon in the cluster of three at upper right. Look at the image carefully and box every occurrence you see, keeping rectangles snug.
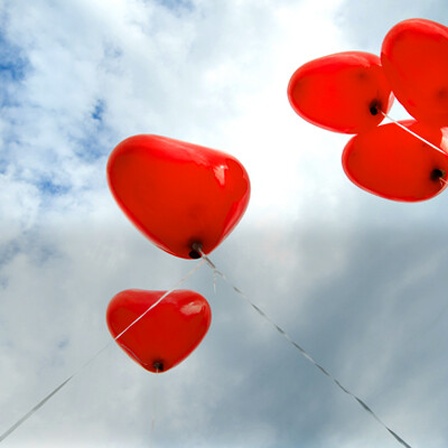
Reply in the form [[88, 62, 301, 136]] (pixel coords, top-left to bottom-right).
[[288, 51, 393, 134]]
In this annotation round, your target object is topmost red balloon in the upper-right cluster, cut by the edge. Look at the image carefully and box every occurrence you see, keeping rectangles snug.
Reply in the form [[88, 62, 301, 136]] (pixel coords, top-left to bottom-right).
[[381, 19, 448, 126]]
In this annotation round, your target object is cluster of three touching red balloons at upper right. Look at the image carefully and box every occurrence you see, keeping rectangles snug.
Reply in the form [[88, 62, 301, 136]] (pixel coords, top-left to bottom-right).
[[288, 19, 448, 202]]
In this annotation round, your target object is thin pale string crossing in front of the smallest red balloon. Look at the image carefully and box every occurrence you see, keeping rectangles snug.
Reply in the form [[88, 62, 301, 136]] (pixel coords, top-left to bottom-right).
[[0, 260, 205, 443]]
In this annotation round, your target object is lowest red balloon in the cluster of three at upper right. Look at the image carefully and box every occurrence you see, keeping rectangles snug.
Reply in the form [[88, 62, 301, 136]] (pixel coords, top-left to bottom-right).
[[342, 120, 448, 202]]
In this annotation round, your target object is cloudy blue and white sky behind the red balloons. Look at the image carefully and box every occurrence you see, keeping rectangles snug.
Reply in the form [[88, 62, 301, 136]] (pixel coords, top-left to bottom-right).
[[0, 0, 448, 448]]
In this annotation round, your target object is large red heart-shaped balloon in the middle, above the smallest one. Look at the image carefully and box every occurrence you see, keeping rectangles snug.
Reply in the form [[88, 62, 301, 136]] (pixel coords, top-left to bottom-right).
[[107, 135, 250, 258]]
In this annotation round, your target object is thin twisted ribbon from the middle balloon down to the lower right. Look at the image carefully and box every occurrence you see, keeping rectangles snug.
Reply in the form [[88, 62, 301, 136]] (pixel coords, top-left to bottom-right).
[[198, 248, 412, 448]]
